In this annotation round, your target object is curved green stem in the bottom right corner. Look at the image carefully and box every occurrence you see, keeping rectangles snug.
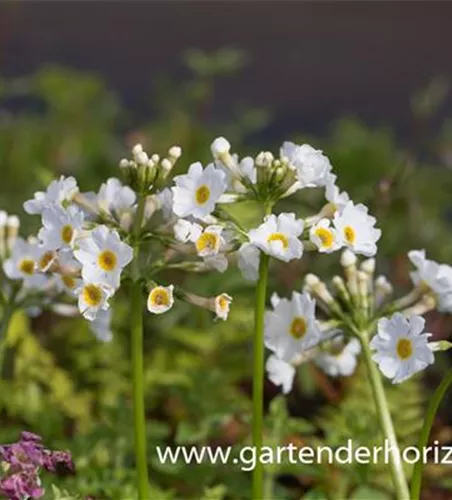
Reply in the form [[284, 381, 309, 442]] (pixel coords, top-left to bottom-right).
[[410, 370, 452, 500]]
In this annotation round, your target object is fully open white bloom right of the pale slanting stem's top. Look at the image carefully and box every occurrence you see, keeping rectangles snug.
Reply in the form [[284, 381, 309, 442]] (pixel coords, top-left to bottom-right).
[[370, 313, 434, 384]]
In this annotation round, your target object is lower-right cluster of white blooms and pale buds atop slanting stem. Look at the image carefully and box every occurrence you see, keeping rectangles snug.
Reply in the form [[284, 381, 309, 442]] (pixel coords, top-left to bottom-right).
[[265, 249, 452, 392]]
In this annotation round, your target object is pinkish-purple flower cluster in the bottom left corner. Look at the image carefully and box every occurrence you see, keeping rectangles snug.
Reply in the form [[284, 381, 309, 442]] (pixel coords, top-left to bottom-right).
[[0, 432, 75, 500]]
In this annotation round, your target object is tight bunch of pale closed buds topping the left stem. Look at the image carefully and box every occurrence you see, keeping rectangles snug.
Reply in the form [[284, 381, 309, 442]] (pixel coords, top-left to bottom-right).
[[119, 144, 182, 194]]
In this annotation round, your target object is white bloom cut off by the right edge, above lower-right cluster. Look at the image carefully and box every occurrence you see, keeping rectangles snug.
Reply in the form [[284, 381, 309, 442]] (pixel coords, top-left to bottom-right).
[[408, 250, 452, 312]]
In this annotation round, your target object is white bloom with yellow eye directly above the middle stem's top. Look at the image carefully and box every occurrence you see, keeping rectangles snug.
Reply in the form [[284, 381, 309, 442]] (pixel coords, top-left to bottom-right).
[[248, 213, 304, 262]]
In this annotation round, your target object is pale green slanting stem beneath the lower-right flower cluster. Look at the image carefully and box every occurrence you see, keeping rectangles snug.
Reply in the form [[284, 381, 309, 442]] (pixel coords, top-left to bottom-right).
[[360, 334, 410, 500]]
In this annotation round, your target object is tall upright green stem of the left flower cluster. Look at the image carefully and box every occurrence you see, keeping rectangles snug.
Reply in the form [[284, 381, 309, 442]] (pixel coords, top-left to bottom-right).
[[131, 196, 149, 500]]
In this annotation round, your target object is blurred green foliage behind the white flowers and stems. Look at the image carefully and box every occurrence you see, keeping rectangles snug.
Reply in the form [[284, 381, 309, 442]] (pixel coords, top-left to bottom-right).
[[0, 5, 452, 500]]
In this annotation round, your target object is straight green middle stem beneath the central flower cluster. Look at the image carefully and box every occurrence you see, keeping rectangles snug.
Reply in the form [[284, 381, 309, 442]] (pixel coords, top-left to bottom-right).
[[252, 253, 269, 500]]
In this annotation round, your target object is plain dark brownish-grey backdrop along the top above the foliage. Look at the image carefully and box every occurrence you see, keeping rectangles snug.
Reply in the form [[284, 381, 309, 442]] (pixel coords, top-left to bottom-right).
[[0, 0, 452, 137]]
